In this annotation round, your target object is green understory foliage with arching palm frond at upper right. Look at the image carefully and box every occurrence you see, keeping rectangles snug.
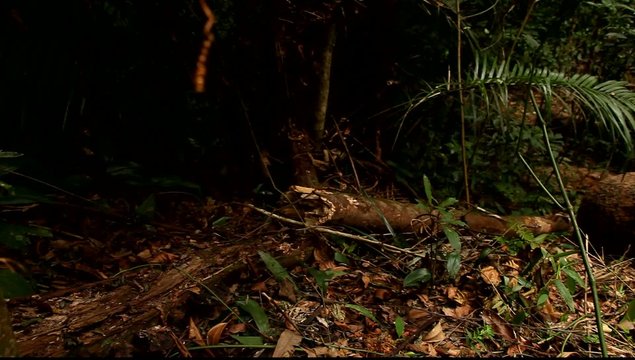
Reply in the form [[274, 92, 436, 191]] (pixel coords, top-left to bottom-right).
[[391, 1, 635, 212]]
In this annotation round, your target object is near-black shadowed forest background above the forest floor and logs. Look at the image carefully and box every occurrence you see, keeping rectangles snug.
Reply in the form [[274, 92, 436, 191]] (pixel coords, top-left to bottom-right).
[[0, 0, 634, 207]]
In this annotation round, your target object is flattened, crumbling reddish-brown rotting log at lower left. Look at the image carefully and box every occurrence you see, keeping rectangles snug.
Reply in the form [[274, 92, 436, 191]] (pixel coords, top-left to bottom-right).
[[14, 258, 209, 357]]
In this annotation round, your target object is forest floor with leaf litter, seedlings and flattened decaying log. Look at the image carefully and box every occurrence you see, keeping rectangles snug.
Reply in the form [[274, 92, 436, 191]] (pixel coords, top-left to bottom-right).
[[6, 188, 635, 357]]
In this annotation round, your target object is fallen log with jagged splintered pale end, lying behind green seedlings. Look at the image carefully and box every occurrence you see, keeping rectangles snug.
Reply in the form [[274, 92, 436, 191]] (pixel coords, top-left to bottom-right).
[[282, 186, 571, 236]]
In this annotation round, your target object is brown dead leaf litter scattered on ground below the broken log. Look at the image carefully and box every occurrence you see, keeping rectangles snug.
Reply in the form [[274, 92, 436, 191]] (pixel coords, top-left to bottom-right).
[[9, 200, 635, 357]]
